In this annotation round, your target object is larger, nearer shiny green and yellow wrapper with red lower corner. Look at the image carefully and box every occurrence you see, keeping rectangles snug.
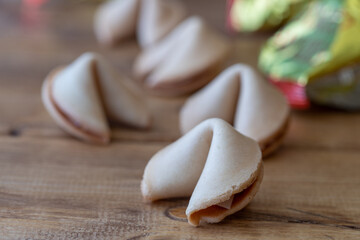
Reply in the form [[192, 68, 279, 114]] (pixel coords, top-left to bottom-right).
[[259, 0, 360, 110]]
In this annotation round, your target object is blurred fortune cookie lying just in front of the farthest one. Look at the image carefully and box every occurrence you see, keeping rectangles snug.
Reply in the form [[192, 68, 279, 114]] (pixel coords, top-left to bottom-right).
[[134, 16, 230, 96]]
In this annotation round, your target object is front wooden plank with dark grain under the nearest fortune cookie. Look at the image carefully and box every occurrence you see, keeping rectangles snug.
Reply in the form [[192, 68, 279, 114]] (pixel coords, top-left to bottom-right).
[[0, 137, 360, 239]]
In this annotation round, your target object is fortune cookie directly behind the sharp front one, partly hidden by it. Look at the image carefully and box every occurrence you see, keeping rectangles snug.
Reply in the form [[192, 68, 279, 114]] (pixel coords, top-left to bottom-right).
[[180, 64, 290, 156]]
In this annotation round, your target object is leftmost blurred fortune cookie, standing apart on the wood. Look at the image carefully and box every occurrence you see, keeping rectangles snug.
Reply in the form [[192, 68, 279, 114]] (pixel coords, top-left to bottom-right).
[[42, 53, 150, 144]]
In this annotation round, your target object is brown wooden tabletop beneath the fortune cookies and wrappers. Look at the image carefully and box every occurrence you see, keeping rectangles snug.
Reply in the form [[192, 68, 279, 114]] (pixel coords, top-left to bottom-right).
[[0, 0, 360, 240]]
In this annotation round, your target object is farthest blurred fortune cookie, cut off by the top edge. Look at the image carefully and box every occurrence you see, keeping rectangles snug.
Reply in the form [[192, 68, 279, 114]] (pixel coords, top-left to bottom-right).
[[94, 0, 186, 47]]
